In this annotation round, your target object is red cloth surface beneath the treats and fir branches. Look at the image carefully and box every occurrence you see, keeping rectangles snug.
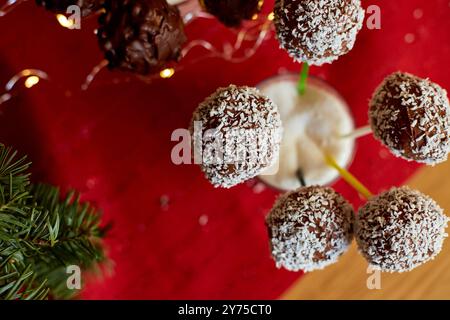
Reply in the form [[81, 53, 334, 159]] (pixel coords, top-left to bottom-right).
[[0, 0, 450, 299]]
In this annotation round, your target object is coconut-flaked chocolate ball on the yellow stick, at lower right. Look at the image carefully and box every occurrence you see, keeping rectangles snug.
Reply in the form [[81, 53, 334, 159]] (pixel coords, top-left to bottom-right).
[[355, 187, 448, 272]]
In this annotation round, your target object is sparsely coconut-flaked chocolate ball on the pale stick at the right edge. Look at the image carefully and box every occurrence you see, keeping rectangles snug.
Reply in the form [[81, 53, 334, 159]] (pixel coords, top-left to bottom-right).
[[369, 72, 450, 165]]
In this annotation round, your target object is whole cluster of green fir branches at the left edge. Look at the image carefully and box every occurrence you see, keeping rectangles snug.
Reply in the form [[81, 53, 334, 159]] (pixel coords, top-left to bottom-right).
[[0, 145, 106, 299]]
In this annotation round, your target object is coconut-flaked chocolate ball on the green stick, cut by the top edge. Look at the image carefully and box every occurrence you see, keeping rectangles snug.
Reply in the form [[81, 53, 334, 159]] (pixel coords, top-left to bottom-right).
[[274, 0, 364, 66]]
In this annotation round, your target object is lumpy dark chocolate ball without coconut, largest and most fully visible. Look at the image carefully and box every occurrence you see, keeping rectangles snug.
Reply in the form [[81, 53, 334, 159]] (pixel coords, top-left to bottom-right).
[[97, 0, 186, 75]]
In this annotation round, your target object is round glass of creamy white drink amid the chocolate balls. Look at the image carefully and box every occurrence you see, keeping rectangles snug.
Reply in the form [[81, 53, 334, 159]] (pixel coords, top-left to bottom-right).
[[257, 73, 355, 191]]
